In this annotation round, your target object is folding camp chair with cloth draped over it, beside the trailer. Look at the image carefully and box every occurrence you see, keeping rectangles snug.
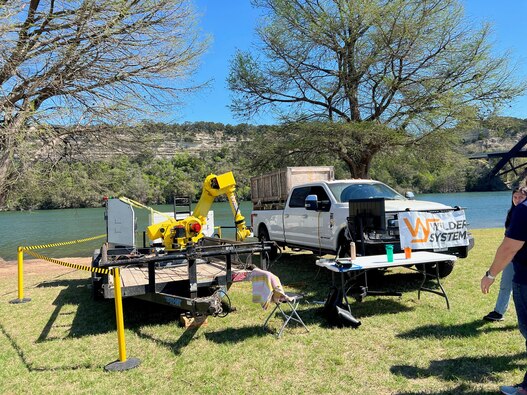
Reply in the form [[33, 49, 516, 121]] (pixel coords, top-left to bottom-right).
[[249, 268, 309, 338]]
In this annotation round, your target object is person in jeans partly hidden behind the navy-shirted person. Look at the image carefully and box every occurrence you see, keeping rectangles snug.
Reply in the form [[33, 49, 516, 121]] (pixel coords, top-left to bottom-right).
[[483, 187, 527, 321]]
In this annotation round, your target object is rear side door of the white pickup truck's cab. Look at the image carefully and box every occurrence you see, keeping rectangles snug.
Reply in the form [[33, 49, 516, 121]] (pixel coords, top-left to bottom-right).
[[284, 187, 317, 246]]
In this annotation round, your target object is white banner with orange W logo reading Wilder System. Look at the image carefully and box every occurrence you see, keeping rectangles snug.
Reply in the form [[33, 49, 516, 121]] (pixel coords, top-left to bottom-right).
[[397, 210, 469, 250]]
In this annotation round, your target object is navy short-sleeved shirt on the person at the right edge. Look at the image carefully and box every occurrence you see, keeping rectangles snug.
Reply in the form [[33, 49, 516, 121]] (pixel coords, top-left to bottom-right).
[[505, 201, 527, 284]]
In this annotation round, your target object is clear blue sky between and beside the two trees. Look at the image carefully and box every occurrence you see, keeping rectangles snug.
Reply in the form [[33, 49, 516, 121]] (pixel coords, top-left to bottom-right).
[[176, 0, 527, 125]]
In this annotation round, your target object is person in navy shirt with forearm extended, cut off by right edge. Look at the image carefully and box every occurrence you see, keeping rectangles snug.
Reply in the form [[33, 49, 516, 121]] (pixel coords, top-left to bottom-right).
[[480, 186, 527, 395]]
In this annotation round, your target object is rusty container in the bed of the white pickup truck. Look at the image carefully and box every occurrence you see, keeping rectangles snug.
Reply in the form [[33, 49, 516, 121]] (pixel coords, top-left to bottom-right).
[[251, 166, 335, 209]]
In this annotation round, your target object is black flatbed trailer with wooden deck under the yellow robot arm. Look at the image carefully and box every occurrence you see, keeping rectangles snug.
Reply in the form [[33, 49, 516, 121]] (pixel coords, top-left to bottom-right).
[[92, 238, 272, 316]]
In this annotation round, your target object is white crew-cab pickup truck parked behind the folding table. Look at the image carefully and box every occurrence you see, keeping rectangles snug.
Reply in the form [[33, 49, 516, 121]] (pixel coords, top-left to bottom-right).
[[251, 179, 473, 277]]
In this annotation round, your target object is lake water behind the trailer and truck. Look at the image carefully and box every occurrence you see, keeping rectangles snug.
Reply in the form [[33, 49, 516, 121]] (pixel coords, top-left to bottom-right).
[[0, 191, 511, 260]]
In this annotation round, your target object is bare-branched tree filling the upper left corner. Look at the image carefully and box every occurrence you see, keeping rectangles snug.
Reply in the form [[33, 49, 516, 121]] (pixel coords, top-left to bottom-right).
[[0, 0, 207, 207]]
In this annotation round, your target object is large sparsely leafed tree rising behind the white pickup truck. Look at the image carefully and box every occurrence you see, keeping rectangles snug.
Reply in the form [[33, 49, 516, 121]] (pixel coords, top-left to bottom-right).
[[228, 0, 524, 177]]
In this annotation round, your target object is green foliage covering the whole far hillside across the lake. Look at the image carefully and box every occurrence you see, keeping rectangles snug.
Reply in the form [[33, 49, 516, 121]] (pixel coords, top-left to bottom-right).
[[2, 118, 525, 210]]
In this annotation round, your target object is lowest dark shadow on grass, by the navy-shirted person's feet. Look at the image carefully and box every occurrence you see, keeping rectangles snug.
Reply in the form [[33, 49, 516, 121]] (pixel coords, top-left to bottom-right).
[[390, 352, 525, 383]]
